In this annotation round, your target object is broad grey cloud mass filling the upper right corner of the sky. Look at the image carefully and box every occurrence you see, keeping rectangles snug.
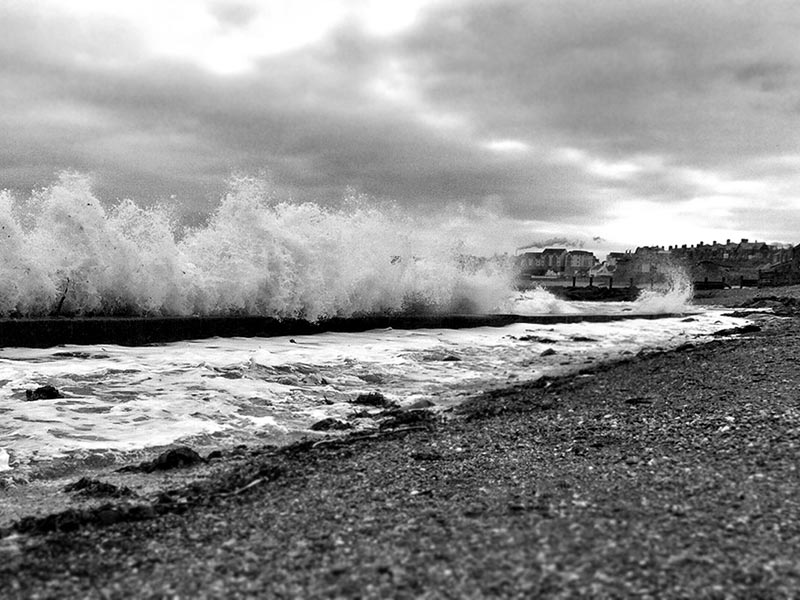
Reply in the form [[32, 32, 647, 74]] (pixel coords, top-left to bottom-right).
[[406, 0, 800, 165]]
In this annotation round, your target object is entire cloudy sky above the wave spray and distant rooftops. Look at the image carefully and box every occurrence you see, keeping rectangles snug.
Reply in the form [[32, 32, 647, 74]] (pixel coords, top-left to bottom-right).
[[0, 0, 800, 252]]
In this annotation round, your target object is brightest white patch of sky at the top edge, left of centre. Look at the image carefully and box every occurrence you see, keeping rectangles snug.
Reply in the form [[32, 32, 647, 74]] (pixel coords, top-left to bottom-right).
[[37, 0, 434, 75]]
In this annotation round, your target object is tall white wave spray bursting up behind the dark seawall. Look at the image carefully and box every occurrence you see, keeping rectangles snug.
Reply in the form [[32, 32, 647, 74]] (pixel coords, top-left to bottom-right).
[[0, 173, 511, 321]]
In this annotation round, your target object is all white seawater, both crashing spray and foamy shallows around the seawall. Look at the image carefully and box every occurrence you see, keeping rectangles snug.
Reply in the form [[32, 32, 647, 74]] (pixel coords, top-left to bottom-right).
[[0, 174, 743, 472]]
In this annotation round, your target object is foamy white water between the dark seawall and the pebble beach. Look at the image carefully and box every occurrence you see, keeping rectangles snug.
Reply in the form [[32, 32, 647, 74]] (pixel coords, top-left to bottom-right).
[[0, 298, 742, 472]]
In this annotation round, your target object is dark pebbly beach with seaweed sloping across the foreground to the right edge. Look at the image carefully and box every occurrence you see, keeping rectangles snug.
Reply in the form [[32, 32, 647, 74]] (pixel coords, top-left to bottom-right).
[[0, 289, 800, 598]]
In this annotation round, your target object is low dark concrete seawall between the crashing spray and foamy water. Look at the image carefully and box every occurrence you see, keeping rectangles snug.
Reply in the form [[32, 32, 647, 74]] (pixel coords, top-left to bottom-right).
[[0, 314, 680, 348]]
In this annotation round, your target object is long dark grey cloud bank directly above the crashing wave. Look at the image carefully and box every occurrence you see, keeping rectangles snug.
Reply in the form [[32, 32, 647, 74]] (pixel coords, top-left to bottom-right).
[[0, 8, 579, 220]]
